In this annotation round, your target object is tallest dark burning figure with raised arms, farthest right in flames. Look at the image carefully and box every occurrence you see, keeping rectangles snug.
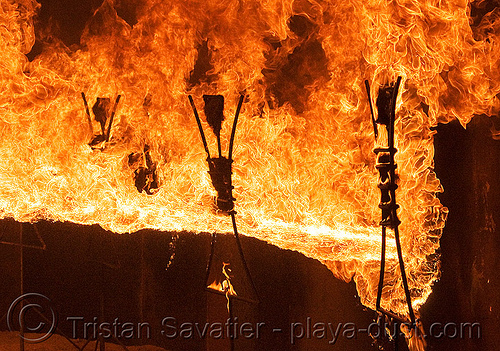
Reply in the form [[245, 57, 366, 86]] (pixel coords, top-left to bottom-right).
[[365, 77, 415, 327]]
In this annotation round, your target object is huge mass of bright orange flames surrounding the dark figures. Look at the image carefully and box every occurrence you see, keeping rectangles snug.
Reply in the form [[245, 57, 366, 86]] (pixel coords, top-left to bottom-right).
[[0, 0, 500, 314]]
